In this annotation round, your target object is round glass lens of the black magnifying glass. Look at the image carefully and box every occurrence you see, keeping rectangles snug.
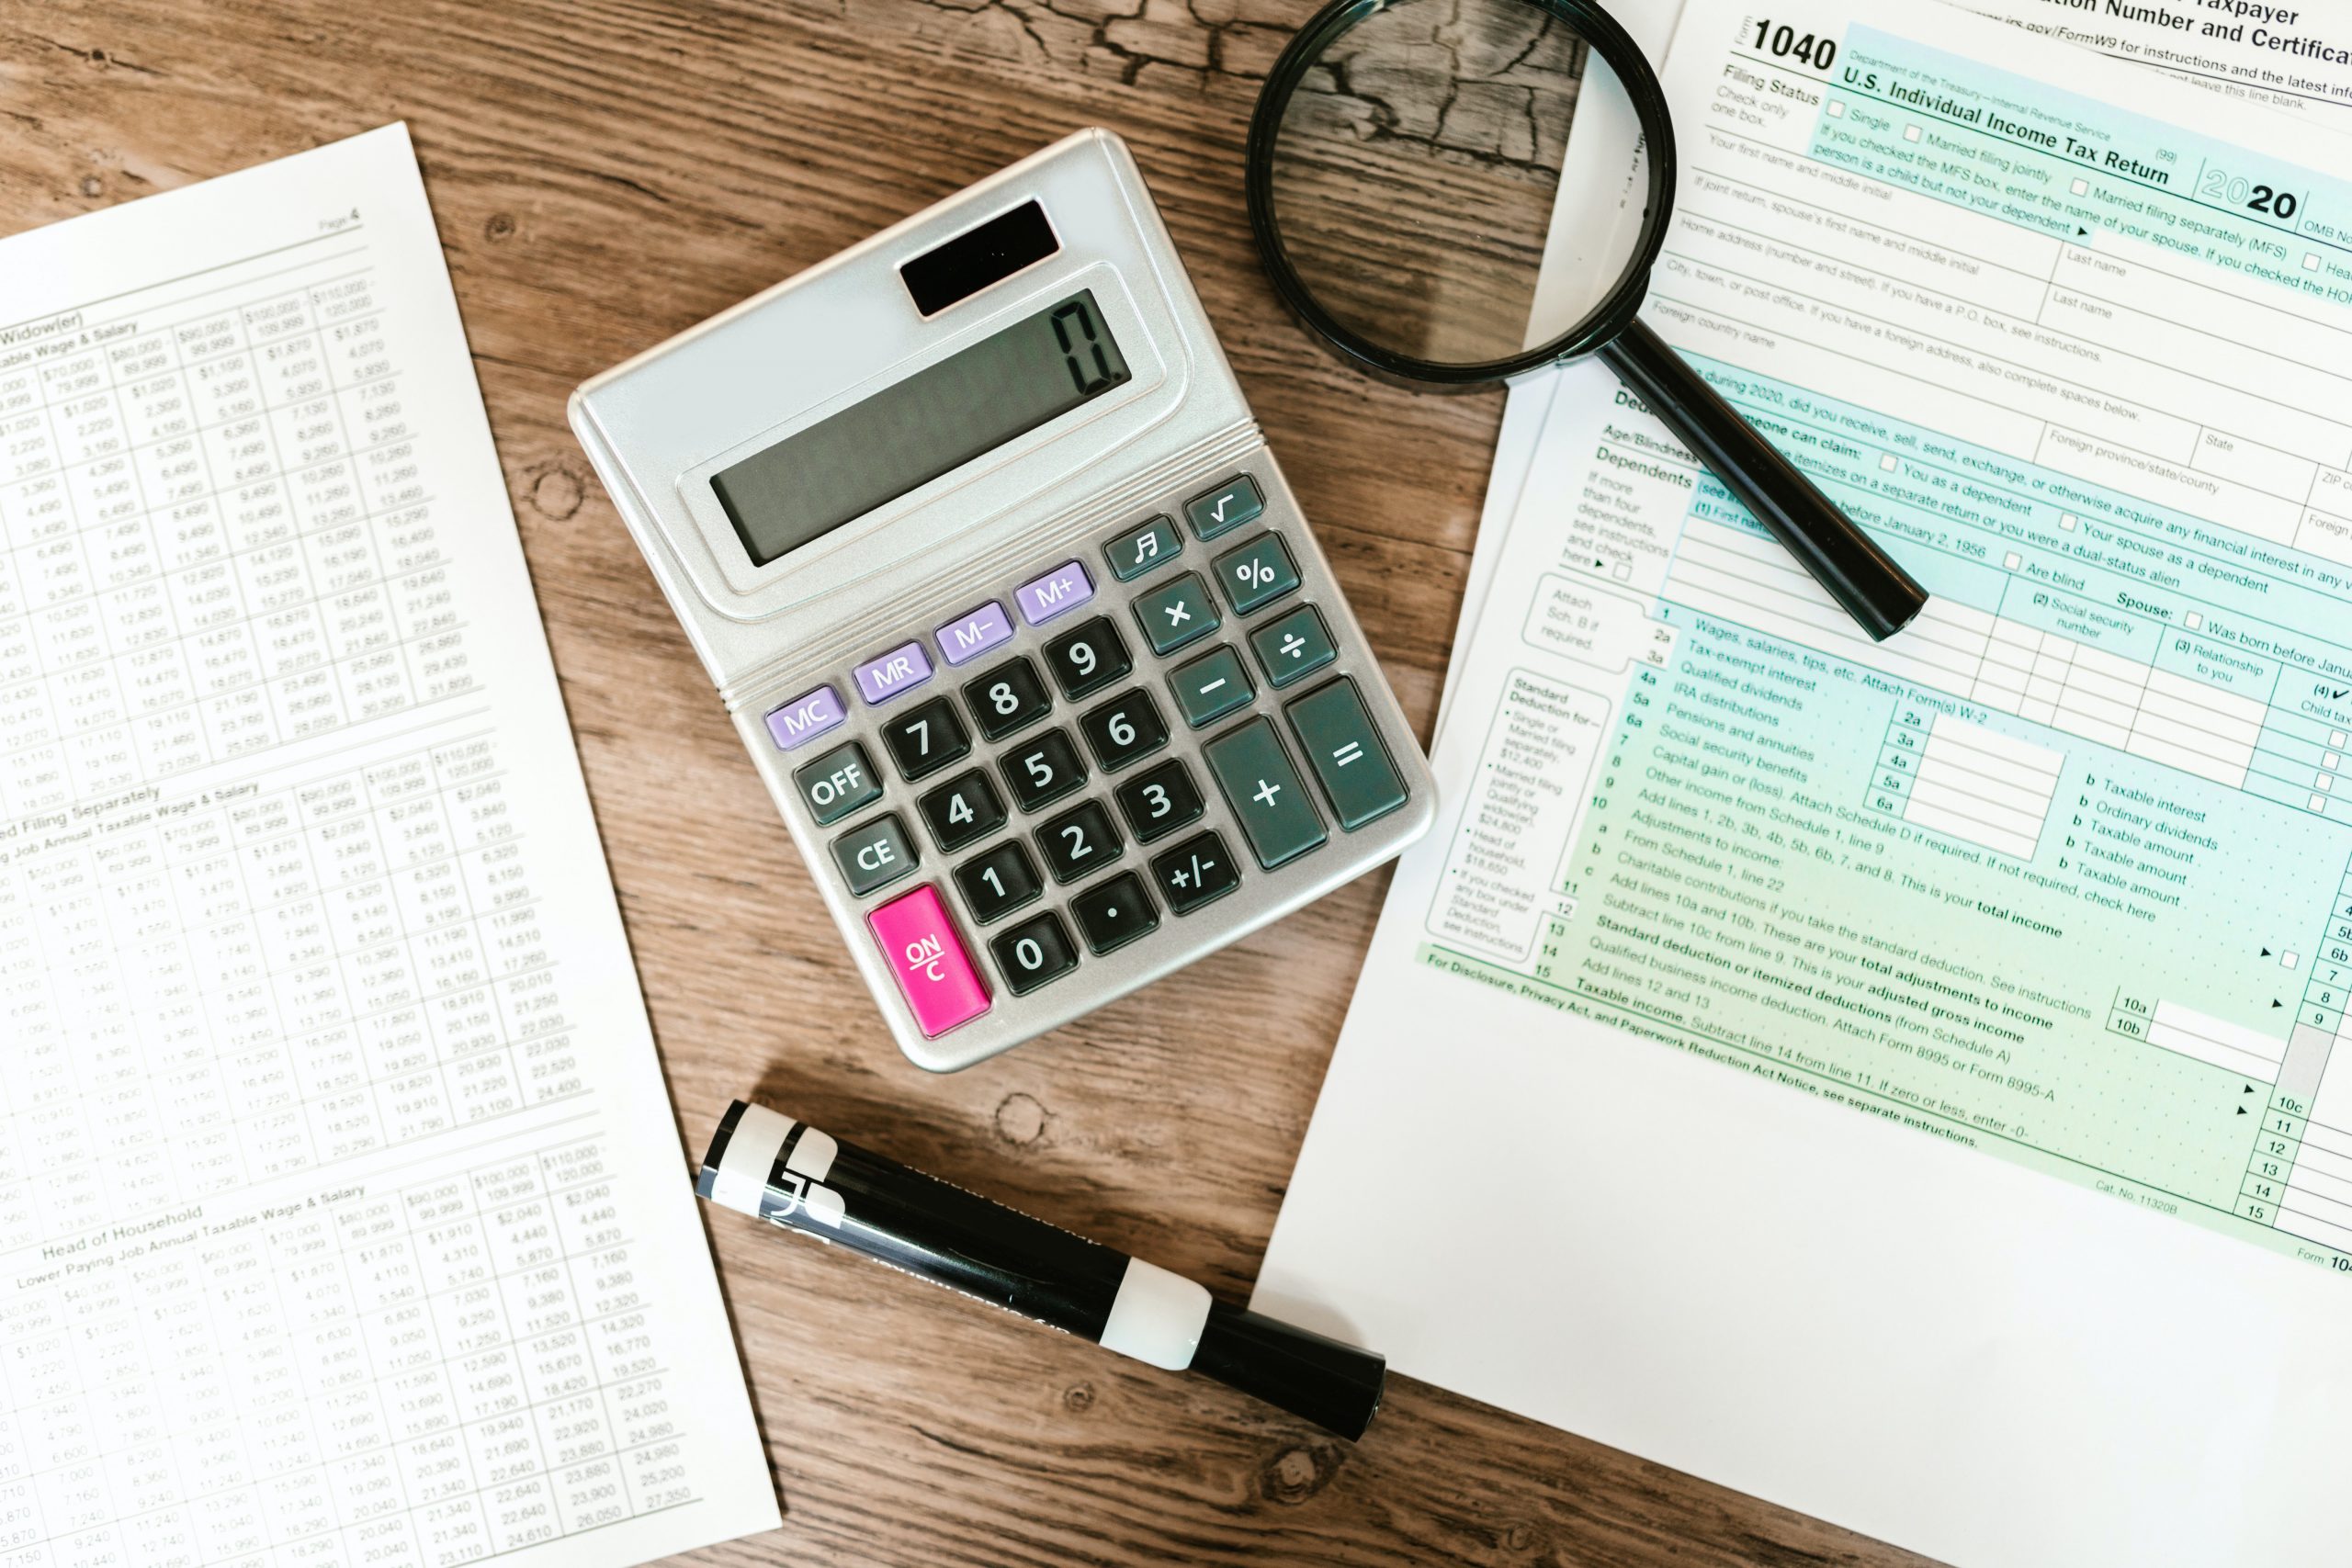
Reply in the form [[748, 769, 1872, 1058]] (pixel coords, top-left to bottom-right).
[[1270, 0, 1649, 367]]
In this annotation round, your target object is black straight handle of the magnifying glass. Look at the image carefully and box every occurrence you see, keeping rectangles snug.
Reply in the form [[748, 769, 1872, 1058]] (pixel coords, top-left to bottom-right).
[[1600, 317, 1927, 642]]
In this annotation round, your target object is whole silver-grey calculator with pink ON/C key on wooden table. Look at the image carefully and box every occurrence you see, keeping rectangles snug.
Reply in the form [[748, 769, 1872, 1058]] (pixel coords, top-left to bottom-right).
[[571, 130, 1435, 1072]]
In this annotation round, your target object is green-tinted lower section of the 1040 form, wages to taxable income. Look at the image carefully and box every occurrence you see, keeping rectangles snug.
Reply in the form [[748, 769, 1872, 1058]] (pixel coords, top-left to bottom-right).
[[1420, 604, 2352, 1267]]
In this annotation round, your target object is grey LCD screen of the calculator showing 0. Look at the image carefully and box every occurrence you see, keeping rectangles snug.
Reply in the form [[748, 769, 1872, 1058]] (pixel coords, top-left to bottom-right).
[[710, 289, 1129, 567]]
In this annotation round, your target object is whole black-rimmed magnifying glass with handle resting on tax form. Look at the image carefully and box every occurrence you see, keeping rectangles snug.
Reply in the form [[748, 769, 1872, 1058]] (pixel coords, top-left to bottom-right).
[[1249, 0, 1927, 639]]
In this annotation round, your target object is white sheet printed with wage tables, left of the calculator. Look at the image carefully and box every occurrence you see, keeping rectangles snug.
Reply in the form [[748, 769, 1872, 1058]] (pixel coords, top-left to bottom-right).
[[0, 125, 776, 1568]]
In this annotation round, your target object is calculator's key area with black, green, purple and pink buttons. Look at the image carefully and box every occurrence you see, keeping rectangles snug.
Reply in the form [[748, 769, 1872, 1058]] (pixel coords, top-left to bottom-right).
[[764, 463, 1411, 1060]]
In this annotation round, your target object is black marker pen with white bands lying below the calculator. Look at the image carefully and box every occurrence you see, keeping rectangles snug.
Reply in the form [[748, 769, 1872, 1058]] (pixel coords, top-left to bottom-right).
[[694, 1100, 1387, 1438]]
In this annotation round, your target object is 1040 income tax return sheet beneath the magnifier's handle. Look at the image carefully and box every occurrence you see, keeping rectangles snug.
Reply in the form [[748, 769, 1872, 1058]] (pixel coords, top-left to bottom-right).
[[1256, 0, 2352, 1565]]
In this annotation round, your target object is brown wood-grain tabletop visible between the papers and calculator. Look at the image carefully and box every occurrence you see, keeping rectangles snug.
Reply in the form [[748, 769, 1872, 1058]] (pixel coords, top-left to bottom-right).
[[14, 0, 1922, 1568]]
